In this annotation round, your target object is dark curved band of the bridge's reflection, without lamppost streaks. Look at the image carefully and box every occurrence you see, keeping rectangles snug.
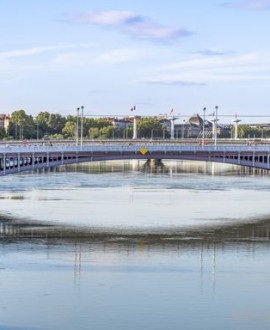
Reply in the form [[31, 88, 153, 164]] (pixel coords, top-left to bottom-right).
[[0, 217, 270, 248]]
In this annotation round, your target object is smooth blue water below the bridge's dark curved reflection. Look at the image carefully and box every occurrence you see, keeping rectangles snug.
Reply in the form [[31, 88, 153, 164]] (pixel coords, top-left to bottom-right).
[[0, 243, 270, 330]]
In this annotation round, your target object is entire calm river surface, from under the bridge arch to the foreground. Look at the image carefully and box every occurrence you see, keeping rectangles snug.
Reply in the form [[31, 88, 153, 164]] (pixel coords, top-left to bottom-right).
[[0, 161, 270, 330]]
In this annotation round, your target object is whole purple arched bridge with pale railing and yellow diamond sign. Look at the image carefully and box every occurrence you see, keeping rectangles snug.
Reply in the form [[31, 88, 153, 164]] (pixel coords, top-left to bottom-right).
[[0, 142, 270, 175]]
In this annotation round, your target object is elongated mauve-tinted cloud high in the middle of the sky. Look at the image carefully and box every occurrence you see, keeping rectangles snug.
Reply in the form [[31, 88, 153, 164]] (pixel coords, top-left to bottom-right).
[[65, 11, 192, 41]]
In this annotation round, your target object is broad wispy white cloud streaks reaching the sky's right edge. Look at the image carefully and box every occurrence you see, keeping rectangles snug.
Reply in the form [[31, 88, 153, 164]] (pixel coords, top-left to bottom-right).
[[144, 52, 270, 86]]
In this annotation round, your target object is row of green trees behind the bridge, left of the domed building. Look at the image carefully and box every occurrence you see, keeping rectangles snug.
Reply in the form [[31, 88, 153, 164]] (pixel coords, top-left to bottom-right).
[[0, 110, 168, 140]]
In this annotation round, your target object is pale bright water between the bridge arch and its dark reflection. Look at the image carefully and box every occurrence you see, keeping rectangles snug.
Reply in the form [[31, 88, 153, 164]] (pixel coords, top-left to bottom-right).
[[0, 162, 270, 230]]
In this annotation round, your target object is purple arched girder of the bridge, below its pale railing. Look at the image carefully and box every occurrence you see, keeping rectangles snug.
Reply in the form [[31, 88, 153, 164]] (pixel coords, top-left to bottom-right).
[[0, 150, 270, 175]]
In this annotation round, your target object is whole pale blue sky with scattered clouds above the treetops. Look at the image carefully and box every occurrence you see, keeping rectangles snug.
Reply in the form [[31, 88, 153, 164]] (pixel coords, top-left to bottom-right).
[[0, 0, 270, 121]]
